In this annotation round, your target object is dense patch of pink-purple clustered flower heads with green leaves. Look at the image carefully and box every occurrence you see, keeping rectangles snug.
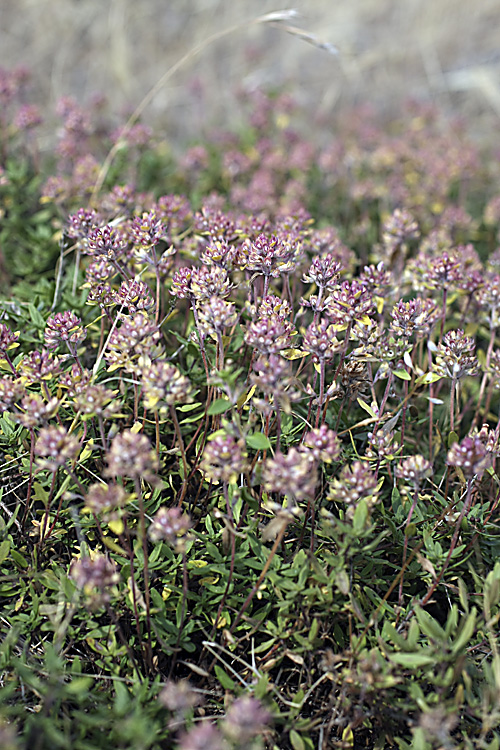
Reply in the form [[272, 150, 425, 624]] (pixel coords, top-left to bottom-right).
[[0, 66, 500, 750]]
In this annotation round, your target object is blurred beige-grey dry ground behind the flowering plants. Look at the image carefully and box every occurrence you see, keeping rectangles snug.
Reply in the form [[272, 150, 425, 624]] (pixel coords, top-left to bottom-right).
[[0, 0, 500, 141]]
